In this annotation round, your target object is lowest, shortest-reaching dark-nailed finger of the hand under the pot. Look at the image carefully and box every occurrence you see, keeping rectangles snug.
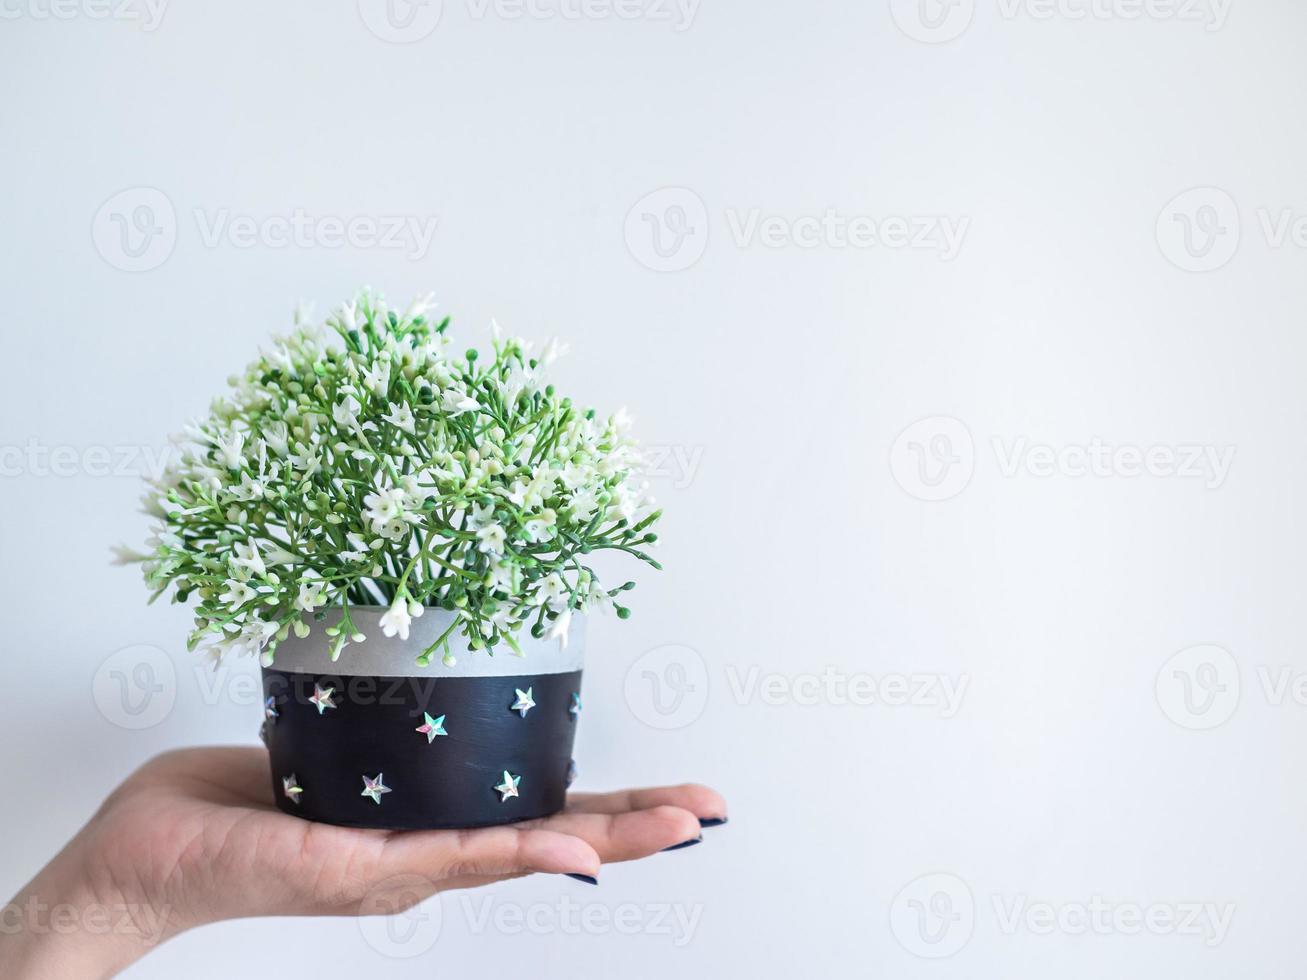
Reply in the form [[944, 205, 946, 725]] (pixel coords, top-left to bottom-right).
[[382, 826, 600, 878]]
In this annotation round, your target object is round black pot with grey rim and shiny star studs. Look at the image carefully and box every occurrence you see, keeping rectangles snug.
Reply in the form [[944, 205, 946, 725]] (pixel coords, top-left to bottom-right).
[[261, 606, 586, 830]]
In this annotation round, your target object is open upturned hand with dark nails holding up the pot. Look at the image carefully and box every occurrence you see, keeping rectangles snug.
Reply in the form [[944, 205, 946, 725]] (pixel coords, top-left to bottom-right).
[[0, 747, 725, 977]]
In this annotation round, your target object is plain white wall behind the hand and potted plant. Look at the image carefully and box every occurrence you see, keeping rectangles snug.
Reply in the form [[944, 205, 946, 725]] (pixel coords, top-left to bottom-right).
[[0, 0, 1307, 980]]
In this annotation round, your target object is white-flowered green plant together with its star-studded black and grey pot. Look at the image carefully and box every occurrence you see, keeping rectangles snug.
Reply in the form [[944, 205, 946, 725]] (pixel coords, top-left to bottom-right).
[[126, 290, 660, 828]]
